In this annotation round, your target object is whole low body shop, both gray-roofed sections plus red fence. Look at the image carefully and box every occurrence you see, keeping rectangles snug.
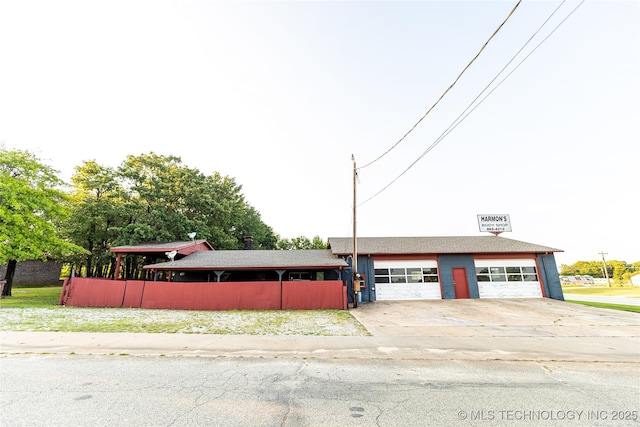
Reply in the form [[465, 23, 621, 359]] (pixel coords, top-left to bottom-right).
[[60, 236, 564, 310]]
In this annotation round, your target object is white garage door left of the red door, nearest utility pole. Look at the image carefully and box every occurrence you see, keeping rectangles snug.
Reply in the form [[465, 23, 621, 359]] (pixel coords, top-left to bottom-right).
[[374, 260, 442, 301]]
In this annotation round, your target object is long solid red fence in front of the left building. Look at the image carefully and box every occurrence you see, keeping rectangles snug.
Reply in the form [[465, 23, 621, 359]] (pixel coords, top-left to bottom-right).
[[59, 277, 347, 310]]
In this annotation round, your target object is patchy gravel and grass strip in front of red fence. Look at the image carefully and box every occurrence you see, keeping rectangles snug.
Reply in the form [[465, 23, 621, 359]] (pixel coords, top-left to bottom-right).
[[0, 307, 370, 336]]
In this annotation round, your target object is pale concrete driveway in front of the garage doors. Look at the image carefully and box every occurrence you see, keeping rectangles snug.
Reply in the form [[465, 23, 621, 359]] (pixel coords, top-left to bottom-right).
[[351, 298, 640, 337]]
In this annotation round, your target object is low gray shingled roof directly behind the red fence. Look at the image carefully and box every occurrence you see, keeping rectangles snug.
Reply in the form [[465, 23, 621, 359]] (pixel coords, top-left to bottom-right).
[[144, 249, 347, 270]]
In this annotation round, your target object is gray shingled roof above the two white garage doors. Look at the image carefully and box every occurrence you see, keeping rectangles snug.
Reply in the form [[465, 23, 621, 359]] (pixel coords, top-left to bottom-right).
[[329, 236, 563, 255]]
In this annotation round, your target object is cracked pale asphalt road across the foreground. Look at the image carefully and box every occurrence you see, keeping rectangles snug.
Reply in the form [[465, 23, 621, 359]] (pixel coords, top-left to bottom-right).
[[0, 355, 640, 427]]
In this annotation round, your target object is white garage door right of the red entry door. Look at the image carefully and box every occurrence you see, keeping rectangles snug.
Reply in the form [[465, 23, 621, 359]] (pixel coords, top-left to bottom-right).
[[475, 259, 542, 298]]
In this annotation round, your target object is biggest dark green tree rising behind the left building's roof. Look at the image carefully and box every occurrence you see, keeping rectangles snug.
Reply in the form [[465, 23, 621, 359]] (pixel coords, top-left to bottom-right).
[[117, 153, 276, 249]]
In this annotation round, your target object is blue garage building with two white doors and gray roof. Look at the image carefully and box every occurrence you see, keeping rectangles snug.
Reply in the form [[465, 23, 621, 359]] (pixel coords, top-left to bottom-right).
[[328, 236, 564, 302]]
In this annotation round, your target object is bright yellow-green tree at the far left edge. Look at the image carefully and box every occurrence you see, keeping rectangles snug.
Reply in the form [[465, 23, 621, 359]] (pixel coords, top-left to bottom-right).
[[0, 145, 83, 296]]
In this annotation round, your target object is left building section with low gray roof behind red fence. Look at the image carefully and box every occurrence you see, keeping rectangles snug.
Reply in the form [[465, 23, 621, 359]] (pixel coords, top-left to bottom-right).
[[60, 242, 348, 310]]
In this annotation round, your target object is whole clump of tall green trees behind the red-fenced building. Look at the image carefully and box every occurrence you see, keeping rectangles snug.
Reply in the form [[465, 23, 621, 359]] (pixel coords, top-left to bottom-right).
[[68, 153, 277, 277]]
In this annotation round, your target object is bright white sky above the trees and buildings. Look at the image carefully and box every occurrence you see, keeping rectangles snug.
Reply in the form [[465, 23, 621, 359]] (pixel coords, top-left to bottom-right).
[[0, 0, 640, 265]]
